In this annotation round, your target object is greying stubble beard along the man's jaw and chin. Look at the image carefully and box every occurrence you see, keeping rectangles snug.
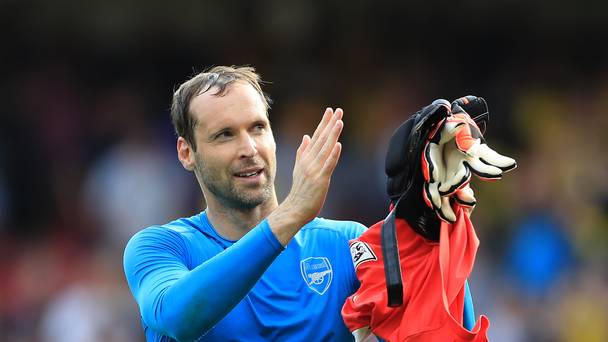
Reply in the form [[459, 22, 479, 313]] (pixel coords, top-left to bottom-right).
[[195, 157, 274, 210]]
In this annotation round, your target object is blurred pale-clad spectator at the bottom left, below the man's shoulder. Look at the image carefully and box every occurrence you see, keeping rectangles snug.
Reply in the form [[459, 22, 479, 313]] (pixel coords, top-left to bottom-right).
[[40, 248, 143, 342]]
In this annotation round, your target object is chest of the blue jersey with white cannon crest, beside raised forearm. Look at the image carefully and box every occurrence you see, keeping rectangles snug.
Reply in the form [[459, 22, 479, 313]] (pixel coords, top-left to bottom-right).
[[195, 236, 355, 341]]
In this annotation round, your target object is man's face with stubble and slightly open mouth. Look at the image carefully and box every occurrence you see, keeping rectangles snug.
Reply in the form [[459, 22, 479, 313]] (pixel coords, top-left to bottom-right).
[[190, 82, 276, 209]]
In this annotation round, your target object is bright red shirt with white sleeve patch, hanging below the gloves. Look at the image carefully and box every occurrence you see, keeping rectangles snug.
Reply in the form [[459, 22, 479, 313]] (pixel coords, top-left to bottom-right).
[[342, 205, 489, 342]]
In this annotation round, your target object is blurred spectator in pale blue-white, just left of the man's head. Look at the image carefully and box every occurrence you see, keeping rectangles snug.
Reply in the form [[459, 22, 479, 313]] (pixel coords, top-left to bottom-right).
[[84, 88, 197, 247]]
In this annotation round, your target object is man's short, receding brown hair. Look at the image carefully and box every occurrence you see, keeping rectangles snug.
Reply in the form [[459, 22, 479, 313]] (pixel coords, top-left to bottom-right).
[[171, 66, 272, 151]]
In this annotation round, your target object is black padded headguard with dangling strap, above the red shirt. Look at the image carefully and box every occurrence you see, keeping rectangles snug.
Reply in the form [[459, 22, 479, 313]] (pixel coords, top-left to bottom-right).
[[382, 96, 488, 306]]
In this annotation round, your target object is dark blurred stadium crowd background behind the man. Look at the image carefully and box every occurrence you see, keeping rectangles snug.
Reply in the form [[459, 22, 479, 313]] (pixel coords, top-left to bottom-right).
[[0, 0, 608, 341]]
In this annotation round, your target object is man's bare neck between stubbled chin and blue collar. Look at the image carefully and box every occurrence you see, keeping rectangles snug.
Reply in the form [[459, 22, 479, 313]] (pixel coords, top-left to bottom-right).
[[206, 196, 278, 240]]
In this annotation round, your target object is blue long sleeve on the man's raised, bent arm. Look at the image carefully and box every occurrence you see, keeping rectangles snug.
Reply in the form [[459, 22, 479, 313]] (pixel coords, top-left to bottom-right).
[[124, 220, 283, 340]]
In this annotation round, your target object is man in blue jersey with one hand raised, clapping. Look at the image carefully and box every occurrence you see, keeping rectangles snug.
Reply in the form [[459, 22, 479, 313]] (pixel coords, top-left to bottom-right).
[[124, 66, 364, 341]]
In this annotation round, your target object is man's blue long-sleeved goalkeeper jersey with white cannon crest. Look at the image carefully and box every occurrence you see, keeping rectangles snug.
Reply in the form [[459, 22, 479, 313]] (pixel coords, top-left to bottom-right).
[[124, 212, 365, 341]]
